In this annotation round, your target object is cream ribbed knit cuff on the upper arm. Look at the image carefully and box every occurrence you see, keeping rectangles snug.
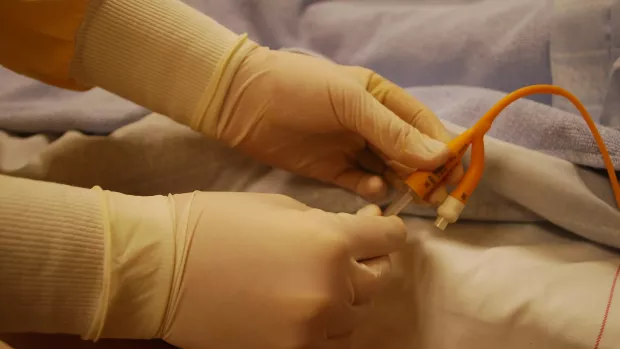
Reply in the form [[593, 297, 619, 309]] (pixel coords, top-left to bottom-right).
[[72, 0, 257, 136]]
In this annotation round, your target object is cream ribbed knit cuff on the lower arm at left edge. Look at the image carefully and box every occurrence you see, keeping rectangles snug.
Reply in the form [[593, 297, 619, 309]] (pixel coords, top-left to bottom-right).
[[0, 176, 104, 334]]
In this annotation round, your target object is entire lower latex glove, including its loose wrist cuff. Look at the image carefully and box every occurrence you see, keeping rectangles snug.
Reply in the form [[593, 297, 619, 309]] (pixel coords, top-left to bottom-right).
[[87, 192, 405, 349]]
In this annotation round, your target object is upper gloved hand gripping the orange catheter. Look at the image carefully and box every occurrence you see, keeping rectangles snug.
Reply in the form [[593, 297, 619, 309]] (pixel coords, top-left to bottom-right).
[[203, 47, 462, 202]]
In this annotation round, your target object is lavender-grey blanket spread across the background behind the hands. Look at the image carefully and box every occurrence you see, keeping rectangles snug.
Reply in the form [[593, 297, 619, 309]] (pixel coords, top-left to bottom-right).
[[0, 0, 620, 169]]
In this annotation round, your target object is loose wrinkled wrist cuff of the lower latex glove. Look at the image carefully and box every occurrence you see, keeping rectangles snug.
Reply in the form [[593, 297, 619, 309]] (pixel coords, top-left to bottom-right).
[[83, 188, 176, 340]]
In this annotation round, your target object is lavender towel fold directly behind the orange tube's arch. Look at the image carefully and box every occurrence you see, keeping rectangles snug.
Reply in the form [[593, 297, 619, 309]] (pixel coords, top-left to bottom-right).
[[408, 86, 620, 171]]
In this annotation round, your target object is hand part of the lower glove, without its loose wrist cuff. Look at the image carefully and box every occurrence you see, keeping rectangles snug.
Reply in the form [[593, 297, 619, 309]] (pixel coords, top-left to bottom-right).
[[140, 193, 405, 349]]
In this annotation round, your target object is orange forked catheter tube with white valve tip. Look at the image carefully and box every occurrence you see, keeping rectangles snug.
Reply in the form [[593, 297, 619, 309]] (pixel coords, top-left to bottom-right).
[[384, 85, 620, 230]]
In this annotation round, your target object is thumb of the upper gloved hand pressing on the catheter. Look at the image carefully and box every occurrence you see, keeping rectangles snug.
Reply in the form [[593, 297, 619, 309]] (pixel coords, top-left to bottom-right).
[[343, 92, 449, 170]]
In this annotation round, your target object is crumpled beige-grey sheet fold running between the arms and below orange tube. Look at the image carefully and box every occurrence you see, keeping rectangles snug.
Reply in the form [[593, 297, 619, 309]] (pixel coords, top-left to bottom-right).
[[0, 114, 620, 247]]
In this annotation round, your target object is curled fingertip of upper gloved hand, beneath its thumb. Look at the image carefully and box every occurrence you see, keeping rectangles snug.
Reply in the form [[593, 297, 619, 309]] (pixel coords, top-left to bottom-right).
[[332, 168, 388, 201]]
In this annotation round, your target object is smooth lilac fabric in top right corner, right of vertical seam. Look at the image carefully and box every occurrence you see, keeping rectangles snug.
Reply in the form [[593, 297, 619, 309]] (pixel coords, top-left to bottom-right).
[[549, 0, 620, 123]]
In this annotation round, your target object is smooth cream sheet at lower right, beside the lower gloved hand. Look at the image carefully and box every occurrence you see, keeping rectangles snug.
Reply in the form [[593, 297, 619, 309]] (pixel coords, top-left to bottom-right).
[[0, 218, 620, 349]]
